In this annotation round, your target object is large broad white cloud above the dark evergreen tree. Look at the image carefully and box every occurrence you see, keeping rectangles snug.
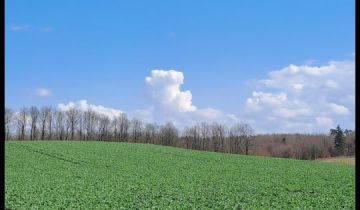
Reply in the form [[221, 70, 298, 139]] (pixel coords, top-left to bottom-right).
[[245, 60, 355, 132]]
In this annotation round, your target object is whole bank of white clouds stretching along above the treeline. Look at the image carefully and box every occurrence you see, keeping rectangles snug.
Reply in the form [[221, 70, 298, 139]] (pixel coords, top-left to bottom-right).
[[58, 57, 355, 132]]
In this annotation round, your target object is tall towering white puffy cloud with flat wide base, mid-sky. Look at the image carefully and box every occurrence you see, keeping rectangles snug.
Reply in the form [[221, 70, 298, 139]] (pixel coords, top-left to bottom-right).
[[141, 70, 239, 129]]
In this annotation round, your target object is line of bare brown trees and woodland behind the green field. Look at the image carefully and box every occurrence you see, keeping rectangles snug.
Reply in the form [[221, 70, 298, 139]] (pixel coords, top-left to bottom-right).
[[5, 106, 355, 159]]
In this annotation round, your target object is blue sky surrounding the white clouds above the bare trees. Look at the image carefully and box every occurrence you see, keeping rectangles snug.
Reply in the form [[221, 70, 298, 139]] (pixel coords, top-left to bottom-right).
[[5, 0, 355, 131]]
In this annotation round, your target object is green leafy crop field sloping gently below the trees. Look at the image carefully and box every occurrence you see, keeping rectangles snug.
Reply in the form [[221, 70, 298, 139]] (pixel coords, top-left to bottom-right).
[[5, 141, 355, 209]]
